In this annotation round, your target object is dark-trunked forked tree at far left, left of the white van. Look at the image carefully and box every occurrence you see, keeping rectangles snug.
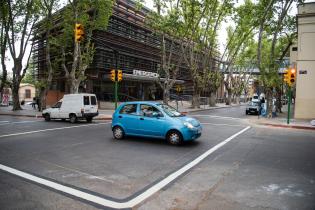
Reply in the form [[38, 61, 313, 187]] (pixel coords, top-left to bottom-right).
[[2, 0, 38, 111]]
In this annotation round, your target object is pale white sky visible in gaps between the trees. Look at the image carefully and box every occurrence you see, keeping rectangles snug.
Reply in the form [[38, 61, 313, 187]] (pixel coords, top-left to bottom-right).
[[3, 0, 315, 74]]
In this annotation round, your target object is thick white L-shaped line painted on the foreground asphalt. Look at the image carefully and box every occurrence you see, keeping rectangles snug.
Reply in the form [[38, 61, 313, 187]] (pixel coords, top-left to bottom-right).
[[0, 126, 250, 209]]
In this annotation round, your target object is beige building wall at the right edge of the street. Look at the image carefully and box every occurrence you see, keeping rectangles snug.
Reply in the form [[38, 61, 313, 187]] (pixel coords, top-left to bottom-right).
[[295, 3, 315, 119]]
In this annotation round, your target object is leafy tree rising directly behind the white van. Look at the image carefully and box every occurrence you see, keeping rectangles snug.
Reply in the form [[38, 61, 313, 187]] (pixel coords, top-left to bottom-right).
[[54, 0, 113, 93]]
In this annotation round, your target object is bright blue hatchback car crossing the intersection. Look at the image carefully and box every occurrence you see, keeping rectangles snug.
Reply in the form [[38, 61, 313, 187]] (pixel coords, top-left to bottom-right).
[[112, 101, 202, 145]]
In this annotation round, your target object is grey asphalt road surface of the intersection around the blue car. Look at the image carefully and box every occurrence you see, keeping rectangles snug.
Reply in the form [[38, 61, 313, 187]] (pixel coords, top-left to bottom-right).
[[0, 107, 315, 209]]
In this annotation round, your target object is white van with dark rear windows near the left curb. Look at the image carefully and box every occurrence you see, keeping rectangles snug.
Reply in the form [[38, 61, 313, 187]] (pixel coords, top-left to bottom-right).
[[42, 93, 98, 123]]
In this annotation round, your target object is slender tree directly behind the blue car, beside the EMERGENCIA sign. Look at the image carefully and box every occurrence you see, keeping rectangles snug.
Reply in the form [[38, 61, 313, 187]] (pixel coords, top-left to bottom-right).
[[147, 0, 185, 104]]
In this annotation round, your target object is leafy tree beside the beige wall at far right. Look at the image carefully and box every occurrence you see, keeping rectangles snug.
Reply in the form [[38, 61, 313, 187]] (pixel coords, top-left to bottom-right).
[[257, 0, 302, 117]]
